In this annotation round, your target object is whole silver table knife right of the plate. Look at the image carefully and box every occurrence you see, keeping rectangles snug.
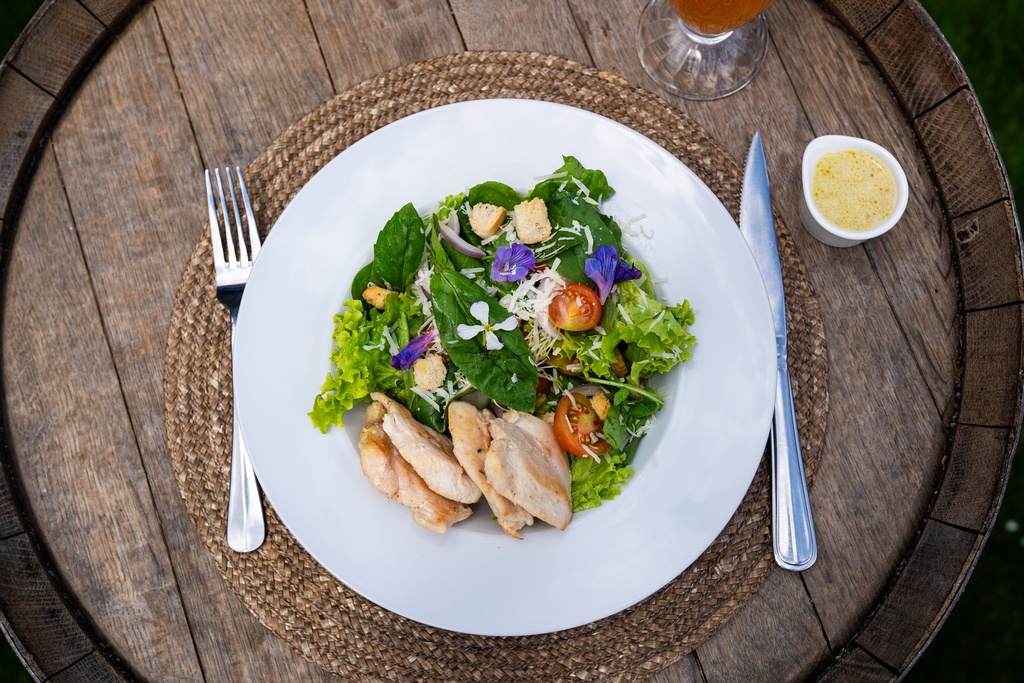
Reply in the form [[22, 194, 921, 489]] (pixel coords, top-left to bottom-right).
[[739, 133, 818, 571]]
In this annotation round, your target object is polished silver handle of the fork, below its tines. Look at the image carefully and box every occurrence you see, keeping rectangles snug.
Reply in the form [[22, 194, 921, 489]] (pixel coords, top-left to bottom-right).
[[227, 313, 266, 553]]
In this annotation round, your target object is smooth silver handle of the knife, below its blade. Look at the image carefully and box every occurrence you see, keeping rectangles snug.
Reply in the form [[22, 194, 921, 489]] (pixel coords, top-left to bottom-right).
[[771, 354, 818, 571]]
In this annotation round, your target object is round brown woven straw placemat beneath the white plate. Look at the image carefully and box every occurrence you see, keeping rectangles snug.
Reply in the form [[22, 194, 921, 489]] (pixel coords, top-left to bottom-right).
[[164, 52, 828, 683]]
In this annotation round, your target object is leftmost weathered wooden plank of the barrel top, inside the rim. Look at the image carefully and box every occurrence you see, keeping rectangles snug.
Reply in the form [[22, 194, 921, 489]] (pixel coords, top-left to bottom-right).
[[3, 141, 199, 680]]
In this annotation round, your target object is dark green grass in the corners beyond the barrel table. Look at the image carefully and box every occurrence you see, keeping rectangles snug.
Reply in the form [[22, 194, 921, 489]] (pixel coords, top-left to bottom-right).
[[0, 0, 1024, 683]]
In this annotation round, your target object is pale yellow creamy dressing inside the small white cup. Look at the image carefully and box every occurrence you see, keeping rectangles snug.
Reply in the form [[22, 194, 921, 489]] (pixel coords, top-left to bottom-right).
[[811, 150, 896, 231]]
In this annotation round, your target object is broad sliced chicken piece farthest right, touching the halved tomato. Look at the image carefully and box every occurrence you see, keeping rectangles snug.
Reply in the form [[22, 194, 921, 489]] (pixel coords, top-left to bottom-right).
[[483, 411, 572, 530]]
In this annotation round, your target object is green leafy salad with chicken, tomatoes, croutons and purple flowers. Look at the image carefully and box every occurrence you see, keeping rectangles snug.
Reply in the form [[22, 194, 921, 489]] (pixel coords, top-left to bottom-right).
[[309, 157, 695, 538]]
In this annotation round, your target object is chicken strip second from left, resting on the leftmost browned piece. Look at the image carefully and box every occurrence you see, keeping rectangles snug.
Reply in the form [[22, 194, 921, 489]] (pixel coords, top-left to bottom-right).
[[371, 392, 480, 505]]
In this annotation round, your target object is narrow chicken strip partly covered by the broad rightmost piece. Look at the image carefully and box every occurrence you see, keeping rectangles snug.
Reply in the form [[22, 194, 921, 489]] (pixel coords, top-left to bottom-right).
[[449, 400, 534, 539]]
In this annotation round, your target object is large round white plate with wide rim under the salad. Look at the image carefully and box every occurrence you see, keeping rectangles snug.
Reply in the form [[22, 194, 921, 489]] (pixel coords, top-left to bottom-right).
[[234, 100, 775, 636]]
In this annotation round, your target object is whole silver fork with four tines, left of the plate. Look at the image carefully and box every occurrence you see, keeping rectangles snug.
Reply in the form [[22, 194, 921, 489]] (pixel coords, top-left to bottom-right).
[[206, 166, 266, 553]]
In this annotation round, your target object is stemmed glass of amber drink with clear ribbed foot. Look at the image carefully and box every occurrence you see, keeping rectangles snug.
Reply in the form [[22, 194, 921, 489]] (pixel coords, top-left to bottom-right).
[[637, 0, 773, 99]]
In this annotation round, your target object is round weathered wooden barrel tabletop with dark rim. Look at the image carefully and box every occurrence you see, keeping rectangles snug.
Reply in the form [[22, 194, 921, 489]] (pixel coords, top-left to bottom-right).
[[0, 0, 1024, 682]]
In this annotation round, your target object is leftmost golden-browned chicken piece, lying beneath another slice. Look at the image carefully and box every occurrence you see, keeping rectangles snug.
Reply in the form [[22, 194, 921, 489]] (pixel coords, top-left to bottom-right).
[[359, 425, 473, 533]]
